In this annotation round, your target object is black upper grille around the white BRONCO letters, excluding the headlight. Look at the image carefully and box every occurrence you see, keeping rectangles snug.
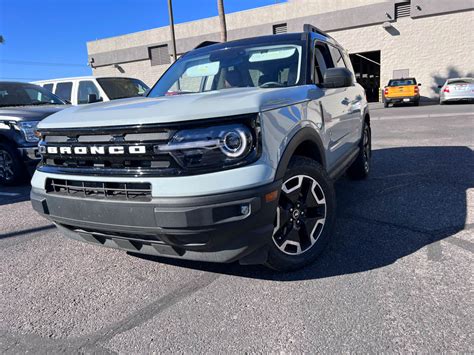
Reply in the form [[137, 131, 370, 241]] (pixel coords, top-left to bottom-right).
[[40, 129, 181, 176]]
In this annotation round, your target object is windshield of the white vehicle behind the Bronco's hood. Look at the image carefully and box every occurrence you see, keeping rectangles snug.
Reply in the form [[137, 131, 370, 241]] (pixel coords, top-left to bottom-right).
[[97, 78, 149, 100]]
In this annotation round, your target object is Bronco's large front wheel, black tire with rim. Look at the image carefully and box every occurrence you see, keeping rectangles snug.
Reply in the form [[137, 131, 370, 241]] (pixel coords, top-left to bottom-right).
[[266, 156, 336, 272]]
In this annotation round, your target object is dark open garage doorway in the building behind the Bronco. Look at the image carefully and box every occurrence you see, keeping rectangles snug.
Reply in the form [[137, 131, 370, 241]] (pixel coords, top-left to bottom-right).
[[350, 51, 380, 102]]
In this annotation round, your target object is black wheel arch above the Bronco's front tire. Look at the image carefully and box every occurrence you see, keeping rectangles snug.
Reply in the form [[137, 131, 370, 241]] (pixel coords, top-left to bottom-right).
[[275, 127, 326, 180]]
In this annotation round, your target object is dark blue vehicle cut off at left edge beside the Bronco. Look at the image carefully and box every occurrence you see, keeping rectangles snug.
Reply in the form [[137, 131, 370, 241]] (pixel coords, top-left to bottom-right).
[[0, 81, 68, 185]]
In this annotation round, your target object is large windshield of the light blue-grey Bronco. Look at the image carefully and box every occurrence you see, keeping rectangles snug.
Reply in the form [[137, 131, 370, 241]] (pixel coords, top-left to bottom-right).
[[149, 43, 302, 97]]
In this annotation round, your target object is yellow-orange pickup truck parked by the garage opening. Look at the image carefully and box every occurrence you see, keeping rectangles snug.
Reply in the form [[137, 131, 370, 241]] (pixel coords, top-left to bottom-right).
[[383, 78, 421, 107]]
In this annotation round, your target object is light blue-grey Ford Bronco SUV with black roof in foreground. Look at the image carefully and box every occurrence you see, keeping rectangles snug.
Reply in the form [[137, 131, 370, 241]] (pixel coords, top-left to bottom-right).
[[31, 25, 371, 270]]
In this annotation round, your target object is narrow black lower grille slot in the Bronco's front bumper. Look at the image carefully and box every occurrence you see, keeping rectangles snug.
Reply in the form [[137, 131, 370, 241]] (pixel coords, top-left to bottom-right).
[[46, 179, 151, 201]]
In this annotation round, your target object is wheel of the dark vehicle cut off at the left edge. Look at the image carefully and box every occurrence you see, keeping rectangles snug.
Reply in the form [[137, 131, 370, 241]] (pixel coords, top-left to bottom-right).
[[0, 142, 27, 186]]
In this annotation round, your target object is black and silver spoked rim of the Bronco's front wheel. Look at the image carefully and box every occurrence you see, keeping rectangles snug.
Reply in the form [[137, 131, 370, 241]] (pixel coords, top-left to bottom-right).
[[273, 175, 326, 255]]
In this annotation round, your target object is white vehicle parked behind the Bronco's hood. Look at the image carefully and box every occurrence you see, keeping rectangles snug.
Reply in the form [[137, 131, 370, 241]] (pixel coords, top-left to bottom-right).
[[34, 76, 149, 105]]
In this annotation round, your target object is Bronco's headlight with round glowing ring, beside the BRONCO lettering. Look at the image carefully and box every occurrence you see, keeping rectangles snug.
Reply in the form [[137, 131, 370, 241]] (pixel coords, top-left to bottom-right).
[[155, 121, 259, 170]]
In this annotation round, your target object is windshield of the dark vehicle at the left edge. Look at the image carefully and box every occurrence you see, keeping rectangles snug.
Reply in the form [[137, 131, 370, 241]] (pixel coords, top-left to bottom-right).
[[0, 82, 65, 107]]
